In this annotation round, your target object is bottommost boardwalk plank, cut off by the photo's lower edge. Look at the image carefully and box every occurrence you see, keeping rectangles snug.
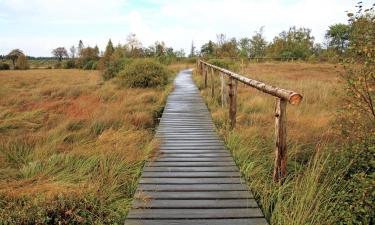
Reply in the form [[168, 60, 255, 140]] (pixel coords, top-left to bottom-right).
[[125, 218, 268, 225]]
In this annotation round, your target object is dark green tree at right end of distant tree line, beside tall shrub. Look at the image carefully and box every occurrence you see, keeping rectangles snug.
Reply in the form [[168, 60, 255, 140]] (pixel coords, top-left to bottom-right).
[[325, 23, 350, 53]]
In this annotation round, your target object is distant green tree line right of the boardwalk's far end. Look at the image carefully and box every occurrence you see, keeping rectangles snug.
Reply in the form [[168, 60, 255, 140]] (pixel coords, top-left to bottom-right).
[[198, 24, 351, 62]]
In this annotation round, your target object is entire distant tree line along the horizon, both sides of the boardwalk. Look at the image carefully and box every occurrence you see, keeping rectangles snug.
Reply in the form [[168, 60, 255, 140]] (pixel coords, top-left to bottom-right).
[[0, 20, 358, 70]]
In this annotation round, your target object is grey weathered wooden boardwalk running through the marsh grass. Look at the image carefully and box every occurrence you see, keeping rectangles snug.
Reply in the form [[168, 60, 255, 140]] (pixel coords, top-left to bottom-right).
[[125, 71, 267, 225]]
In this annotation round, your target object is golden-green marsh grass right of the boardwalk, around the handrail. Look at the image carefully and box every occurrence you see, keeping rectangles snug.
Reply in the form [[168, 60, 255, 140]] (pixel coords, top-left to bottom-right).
[[194, 63, 349, 225]]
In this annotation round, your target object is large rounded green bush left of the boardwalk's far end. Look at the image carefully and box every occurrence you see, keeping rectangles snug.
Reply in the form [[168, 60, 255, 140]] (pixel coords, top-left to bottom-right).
[[119, 60, 168, 88]]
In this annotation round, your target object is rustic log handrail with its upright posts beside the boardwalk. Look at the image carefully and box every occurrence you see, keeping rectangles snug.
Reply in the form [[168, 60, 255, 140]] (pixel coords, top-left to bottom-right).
[[197, 59, 303, 182]]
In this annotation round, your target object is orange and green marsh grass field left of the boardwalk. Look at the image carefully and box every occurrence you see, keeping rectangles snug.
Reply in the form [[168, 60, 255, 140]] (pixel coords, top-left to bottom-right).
[[0, 65, 182, 224]]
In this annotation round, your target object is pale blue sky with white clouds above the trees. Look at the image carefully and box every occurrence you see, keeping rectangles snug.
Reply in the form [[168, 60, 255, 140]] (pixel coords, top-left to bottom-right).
[[0, 0, 374, 56]]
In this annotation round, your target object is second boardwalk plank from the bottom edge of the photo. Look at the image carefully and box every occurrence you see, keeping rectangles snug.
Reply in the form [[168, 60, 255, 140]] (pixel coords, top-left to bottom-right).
[[128, 208, 263, 219]]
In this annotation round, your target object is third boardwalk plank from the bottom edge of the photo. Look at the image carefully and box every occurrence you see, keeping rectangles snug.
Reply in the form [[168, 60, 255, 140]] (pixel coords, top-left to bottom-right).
[[133, 199, 258, 209]]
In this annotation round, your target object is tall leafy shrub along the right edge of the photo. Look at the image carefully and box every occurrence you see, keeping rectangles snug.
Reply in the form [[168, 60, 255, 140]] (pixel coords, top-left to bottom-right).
[[332, 3, 375, 224]]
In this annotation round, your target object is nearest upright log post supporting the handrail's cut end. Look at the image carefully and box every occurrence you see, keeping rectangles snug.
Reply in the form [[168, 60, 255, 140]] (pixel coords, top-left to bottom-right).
[[273, 98, 287, 182]]
